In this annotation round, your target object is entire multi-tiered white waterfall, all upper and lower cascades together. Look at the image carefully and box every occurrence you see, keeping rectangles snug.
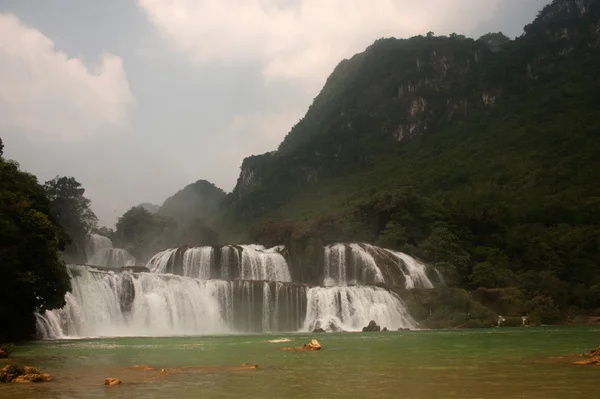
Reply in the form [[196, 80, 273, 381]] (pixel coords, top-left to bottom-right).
[[36, 241, 443, 338]]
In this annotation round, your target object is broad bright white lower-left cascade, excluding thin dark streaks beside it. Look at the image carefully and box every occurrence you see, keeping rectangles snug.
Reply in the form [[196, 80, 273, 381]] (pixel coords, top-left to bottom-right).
[[36, 265, 231, 338]]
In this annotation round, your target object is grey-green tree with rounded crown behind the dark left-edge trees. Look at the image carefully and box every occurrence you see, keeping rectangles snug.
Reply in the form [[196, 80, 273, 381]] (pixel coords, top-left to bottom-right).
[[44, 176, 98, 262]]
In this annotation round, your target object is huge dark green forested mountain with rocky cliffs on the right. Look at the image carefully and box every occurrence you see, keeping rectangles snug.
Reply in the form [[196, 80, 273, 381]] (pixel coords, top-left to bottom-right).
[[213, 0, 600, 314]]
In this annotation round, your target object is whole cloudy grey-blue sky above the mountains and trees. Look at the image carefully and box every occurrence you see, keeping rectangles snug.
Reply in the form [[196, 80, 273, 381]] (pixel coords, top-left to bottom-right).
[[0, 0, 549, 226]]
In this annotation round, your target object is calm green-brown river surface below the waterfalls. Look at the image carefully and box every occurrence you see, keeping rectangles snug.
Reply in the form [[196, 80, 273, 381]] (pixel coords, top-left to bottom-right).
[[0, 326, 600, 399]]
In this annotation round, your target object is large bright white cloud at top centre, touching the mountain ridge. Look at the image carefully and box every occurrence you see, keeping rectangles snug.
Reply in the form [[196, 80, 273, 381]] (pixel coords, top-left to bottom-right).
[[138, 0, 500, 89]]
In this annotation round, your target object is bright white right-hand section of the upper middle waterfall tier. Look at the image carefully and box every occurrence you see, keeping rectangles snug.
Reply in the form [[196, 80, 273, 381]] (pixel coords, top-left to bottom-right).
[[240, 245, 292, 282]]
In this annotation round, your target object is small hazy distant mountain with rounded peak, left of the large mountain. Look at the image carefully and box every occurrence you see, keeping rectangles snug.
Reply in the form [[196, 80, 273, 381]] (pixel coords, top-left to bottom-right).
[[157, 180, 225, 225]]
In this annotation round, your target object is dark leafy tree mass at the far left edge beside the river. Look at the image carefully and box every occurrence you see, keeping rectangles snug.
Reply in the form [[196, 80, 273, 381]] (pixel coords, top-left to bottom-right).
[[0, 148, 71, 342]]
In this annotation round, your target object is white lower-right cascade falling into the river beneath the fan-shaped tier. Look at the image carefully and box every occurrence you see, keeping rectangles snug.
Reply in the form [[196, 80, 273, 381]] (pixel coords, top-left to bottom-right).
[[304, 287, 416, 331]]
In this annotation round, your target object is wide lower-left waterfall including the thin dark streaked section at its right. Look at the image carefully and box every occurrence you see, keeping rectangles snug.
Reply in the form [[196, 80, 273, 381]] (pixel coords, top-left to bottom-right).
[[36, 265, 307, 338]]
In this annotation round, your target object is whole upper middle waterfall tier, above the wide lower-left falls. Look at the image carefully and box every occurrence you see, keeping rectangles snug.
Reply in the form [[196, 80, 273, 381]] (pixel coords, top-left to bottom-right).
[[146, 245, 292, 282]]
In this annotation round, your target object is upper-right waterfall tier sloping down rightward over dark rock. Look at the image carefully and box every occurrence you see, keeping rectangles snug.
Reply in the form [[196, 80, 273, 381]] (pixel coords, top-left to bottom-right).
[[323, 244, 436, 289]]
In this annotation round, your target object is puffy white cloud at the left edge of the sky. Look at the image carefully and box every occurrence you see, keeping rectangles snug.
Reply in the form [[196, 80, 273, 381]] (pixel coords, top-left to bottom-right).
[[0, 13, 134, 139]]
